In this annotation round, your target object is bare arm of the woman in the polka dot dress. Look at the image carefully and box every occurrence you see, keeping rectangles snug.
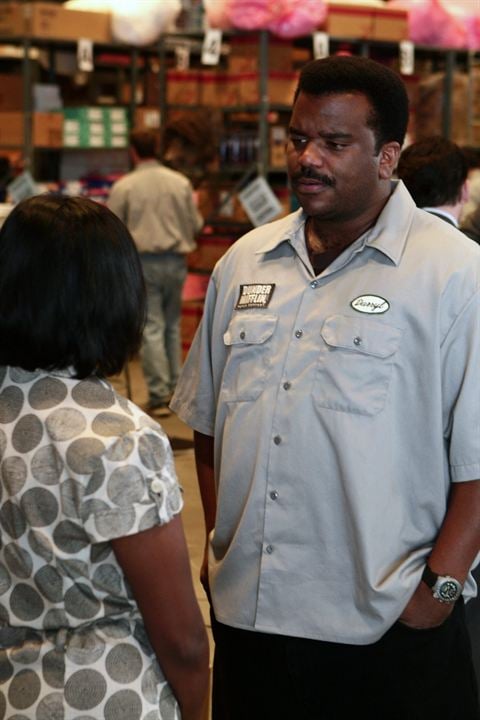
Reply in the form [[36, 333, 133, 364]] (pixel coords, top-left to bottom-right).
[[112, 515, 209, 720]]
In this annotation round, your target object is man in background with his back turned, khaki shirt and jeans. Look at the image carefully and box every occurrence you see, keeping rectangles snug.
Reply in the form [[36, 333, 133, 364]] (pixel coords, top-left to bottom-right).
[[107, 130, 203, 417]]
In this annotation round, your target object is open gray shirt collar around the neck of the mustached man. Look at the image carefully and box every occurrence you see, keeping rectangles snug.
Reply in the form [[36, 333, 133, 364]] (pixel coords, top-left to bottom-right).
[[256, 180, 416, 265]]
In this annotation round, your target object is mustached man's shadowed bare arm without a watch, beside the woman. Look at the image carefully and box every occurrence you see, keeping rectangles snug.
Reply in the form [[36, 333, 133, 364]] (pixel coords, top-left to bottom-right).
[[193, 432, 217, 599]]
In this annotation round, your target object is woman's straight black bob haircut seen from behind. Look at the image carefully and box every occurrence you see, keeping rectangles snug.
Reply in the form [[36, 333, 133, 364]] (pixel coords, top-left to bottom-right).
[[0, 195, 145, 378]]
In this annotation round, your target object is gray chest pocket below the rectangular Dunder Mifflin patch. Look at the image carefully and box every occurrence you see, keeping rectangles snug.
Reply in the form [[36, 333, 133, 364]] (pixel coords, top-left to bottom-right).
[[221, 314, 277, 402]]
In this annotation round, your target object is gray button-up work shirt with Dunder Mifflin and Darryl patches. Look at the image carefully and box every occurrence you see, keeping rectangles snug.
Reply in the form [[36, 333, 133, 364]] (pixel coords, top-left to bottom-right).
[[172, 183, 480, 644]]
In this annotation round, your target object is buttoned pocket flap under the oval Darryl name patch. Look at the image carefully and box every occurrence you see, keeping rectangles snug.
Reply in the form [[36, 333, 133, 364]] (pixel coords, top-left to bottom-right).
[[321, 315, 403, 358]]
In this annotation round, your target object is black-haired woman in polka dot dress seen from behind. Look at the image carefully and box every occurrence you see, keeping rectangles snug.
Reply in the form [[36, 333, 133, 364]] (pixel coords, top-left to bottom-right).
[[0, 195, 208, 720]]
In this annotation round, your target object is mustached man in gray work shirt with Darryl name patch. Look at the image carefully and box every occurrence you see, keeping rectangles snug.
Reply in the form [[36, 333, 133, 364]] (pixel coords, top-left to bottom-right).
[[171, 57, 480, 720]]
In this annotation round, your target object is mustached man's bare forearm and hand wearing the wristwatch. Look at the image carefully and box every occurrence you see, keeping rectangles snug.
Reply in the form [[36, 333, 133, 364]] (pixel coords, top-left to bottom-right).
[[400, 480, 480, 628]]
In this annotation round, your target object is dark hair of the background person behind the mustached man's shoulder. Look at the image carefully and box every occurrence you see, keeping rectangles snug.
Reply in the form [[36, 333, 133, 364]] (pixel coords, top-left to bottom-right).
[[397, 136, 468, 207]]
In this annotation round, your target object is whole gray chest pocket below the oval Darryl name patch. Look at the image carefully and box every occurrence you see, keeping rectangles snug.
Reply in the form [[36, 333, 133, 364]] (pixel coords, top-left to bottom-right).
[[313, 315, 403, 415]]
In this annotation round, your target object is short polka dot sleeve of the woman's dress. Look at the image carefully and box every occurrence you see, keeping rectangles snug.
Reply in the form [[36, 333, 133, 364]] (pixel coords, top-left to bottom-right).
[[79, 426, 183, 543]]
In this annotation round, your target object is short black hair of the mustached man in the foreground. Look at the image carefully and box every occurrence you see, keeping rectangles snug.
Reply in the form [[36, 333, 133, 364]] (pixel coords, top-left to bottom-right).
[[295, 55, 409, 153]]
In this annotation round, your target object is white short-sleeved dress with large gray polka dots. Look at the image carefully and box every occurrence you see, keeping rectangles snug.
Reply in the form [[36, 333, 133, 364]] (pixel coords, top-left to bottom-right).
[[0, 367, 182, 720]]
